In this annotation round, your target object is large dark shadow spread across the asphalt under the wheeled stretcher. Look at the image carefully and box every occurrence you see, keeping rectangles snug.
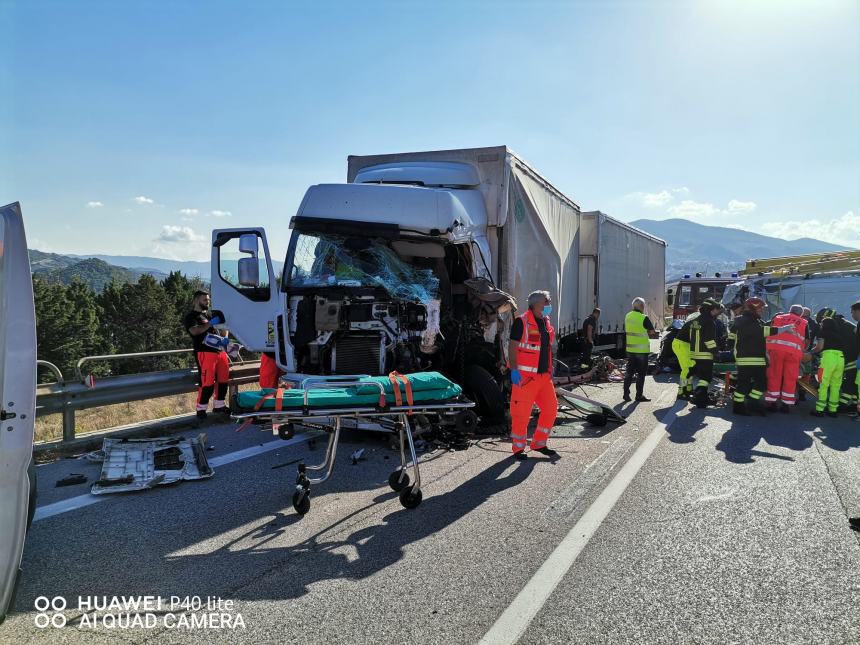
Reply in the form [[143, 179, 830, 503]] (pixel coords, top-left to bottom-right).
[[15, 442, 536, 612]]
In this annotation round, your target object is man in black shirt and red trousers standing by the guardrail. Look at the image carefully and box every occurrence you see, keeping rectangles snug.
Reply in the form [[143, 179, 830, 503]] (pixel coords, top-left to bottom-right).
[[183, 291, 230, 419]]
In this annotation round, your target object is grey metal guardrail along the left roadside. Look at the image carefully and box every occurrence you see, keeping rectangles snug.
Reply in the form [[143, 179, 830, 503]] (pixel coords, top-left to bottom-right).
[[36, 350, 260, 442]]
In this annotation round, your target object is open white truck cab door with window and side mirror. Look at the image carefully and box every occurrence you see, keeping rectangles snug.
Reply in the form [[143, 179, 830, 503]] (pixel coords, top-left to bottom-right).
[[211, 228, 279, 352]]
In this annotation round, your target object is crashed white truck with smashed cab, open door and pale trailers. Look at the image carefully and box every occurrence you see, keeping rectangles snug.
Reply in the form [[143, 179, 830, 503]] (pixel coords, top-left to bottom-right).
[[212, 146, 665, 417]]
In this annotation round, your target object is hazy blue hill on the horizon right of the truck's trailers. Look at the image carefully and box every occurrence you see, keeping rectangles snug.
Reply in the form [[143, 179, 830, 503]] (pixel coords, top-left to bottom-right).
[[630, 219, 850, 279]]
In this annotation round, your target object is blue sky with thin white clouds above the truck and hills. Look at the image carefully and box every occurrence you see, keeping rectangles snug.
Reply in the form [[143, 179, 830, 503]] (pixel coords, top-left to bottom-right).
[[0, 0, 860, 259]]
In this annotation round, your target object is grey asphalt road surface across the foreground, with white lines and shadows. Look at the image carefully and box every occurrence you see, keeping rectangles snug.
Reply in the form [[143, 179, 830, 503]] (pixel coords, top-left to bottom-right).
[[6, 378, 860, 645]]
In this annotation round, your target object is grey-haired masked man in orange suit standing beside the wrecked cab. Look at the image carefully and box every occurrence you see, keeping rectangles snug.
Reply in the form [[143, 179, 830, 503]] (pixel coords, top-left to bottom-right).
[[508, 291, 558, 460]]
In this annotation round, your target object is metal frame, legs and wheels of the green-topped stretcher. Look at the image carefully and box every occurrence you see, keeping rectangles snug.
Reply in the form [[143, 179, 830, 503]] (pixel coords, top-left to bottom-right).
[[230, 374, 475, 515]]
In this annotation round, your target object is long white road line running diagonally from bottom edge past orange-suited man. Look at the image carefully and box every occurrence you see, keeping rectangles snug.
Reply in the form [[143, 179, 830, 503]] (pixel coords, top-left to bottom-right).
[[479, 401, 685, 645]]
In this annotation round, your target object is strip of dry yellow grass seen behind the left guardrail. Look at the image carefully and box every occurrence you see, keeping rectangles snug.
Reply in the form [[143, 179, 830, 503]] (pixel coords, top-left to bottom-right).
[[35, 383, 259, 441]]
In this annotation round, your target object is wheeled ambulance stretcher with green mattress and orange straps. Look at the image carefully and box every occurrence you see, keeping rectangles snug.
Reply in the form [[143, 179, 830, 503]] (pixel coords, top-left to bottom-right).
[[230, 372, 477, 515]]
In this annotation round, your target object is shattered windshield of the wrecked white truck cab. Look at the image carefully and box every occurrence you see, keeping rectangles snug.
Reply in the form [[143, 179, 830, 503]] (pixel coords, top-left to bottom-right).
[[287, 233, 439, 302]]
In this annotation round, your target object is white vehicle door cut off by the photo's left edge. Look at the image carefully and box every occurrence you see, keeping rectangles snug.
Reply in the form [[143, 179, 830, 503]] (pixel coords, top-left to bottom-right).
[[0, 203, 36, 622]]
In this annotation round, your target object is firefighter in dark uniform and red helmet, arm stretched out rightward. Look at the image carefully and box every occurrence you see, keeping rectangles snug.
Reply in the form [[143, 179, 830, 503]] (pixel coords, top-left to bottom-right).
[[732, 298, 793, 416]]
